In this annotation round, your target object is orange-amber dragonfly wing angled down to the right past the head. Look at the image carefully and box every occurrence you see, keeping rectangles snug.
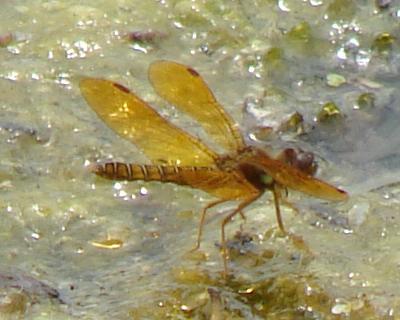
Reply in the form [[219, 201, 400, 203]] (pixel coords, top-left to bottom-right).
[[246, 155, 348, 201]]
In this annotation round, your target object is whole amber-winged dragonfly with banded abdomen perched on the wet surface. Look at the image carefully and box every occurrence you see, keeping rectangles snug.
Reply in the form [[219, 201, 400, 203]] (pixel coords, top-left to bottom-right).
[[80, 60, 347, 275]]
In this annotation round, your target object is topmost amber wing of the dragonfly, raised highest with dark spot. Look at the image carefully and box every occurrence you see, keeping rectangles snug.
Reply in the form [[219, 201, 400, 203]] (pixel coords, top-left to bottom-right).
[[149, 61, 244, 152]]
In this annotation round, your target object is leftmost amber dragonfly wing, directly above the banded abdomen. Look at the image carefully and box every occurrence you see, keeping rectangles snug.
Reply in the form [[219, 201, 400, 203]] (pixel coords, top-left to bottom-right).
[[80, 78, 217, 166]]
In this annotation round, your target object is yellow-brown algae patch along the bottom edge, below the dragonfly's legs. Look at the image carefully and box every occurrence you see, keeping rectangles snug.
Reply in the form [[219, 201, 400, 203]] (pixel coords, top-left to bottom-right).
[[130, 273, 379, 320]]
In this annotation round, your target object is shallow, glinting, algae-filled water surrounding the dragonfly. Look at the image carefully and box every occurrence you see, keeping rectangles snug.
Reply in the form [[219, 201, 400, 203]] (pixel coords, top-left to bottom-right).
[[0, 0, 400, 319]]
